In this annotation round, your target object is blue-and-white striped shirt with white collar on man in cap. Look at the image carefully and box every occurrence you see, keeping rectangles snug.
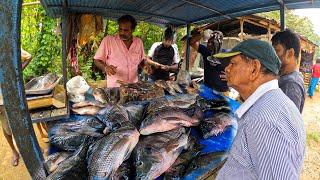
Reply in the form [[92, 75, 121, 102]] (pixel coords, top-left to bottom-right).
[[217, 80, 306, 180]]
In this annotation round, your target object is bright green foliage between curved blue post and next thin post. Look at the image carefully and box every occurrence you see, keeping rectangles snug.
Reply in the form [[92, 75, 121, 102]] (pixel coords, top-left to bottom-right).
[[21, 3, 61, 80]]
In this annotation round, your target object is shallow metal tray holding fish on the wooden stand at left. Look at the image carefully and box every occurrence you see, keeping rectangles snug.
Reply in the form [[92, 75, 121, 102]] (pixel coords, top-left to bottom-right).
[[25, 76, 61, 95]]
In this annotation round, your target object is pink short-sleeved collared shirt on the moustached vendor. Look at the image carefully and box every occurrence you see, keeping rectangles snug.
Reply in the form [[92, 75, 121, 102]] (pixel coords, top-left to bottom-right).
[[94, 34, 144, 87]]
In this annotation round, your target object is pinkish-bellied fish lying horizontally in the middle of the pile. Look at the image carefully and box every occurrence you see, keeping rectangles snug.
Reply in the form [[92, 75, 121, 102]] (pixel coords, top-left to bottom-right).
[[139, 106, 203, 135]]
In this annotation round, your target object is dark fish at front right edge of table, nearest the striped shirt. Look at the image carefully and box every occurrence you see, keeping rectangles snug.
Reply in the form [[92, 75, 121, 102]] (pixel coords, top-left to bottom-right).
[[183, 153, 227, 180]]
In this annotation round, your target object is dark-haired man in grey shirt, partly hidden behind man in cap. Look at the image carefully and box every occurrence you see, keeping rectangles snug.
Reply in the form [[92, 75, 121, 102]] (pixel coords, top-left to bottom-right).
[[271, 30, 306, 113]]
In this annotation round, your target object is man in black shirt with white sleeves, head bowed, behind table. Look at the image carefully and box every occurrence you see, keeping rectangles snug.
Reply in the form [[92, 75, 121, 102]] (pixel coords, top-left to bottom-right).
[[147, 28, 179, 81]]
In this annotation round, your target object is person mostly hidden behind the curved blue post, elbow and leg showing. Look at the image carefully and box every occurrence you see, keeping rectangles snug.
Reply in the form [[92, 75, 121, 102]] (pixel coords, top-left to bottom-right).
[[0, 48, 32, 166]]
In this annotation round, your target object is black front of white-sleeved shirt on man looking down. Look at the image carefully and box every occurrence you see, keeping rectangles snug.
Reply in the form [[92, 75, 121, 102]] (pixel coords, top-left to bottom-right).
[[151, 43, 174, 80]]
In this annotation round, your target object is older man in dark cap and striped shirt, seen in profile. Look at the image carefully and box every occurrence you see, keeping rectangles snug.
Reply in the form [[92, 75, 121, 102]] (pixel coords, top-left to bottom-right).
[[214, 39, 306, 180]]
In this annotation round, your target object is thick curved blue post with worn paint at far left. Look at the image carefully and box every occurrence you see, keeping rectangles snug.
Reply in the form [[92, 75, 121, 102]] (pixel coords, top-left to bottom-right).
[[0, 0, 46, 179]]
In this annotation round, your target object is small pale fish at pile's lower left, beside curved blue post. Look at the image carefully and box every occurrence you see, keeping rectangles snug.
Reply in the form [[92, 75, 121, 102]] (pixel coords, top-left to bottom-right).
[[44, 152, 72, 173]]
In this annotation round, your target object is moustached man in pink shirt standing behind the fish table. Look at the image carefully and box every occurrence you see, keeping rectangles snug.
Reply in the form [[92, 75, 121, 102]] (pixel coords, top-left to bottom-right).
[[94, 15, 144, 87]]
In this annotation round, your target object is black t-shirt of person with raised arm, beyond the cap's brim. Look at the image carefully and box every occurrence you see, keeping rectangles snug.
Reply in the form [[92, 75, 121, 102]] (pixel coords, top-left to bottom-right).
[[198, 44, 229, 92]]
